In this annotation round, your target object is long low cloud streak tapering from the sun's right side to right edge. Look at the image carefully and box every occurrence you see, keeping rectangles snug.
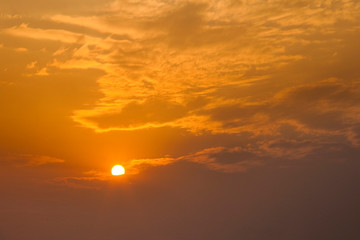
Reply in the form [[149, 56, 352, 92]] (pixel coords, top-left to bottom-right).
[[126, 132, 358, 174]]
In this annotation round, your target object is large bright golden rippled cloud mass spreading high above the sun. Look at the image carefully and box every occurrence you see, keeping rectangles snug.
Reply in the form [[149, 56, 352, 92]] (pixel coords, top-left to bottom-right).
[[3, 1, 359, 135]]
